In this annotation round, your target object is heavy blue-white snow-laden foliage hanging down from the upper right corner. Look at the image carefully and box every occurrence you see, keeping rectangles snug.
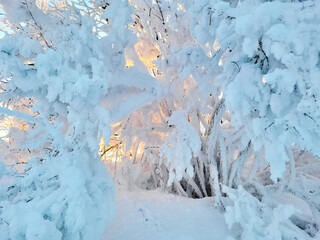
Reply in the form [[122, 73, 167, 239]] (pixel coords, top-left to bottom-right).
[[189, 0, 320, 180]]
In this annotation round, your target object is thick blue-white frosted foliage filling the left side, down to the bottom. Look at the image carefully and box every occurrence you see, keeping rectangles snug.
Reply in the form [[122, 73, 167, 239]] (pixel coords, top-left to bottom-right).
[[0, 0, 155, 240]]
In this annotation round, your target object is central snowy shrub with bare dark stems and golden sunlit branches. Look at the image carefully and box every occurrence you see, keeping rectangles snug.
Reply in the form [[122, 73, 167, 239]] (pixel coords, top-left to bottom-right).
[[102, 1, 251, 202]]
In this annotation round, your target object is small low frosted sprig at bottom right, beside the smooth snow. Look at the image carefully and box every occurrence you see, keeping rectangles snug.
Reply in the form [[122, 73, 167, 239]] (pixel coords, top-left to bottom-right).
[[223, 185, 311, 240]]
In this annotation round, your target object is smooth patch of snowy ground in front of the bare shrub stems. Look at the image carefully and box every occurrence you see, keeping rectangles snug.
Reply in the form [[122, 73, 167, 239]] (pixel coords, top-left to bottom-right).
[[102, 191, 232, 240]]
